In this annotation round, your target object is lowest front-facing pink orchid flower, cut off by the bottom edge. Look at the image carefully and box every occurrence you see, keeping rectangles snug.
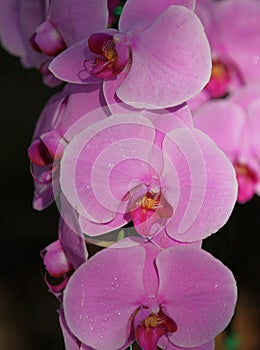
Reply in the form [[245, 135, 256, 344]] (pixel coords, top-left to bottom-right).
[[63, 240, 236, 350]]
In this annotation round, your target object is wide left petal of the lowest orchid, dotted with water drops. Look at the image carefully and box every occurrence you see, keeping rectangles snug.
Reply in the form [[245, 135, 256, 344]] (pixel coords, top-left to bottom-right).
[[64, 246, 146, 350]]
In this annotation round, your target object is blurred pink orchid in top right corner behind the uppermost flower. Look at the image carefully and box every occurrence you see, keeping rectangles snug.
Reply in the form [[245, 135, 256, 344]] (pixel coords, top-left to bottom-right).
[[189, 0, 260, 109]]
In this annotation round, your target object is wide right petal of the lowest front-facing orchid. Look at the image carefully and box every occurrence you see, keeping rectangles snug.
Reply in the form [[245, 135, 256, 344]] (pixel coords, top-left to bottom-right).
[[156, 247, 237, 348]]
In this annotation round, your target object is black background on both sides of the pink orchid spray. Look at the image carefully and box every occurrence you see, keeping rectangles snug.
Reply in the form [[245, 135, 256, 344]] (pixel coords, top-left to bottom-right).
[[0, 49, 260, 350]]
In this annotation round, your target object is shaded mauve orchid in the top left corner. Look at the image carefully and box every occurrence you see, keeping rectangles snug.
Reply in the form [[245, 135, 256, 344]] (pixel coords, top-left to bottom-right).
[[0, 0, 108, 86]]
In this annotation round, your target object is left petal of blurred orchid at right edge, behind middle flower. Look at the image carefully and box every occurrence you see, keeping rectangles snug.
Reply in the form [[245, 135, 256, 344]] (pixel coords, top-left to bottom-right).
[[193, 100, 246, 161]]
